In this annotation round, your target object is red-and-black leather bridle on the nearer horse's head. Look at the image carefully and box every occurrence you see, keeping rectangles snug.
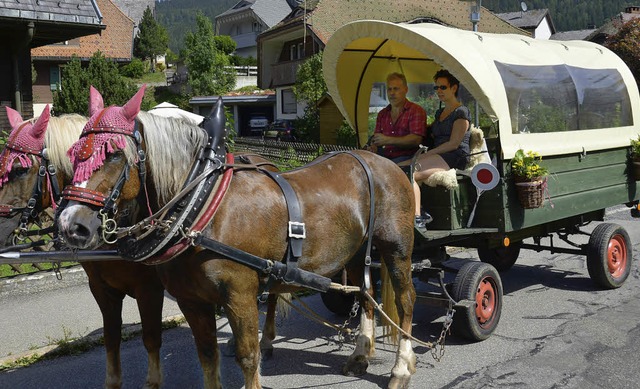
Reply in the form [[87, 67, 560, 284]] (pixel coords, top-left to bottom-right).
[[61, 108, 148, 244]]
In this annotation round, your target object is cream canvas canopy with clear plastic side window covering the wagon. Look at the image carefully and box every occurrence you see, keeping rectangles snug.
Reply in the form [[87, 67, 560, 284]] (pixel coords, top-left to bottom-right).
[[323, 20, 640, 159]]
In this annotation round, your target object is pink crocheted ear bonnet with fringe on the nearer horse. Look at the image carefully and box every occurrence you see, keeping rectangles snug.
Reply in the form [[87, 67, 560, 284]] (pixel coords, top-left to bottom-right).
[[67, 85, 146, 184]]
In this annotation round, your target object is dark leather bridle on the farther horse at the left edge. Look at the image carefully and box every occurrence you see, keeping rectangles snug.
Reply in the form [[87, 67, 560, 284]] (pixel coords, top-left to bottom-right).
[[0, 122, 60, 244]]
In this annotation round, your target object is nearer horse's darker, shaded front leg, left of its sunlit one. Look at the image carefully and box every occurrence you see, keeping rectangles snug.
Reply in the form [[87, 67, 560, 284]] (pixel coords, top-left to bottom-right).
[[177, 298, 222, 389]]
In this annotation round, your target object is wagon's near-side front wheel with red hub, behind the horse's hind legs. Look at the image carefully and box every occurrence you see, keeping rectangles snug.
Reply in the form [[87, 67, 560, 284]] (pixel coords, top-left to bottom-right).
[[452, 262, 502, 341]]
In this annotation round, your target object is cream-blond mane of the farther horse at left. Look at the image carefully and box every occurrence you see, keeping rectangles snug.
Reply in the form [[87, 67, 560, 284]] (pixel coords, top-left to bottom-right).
[[44, 113, 88, 177]]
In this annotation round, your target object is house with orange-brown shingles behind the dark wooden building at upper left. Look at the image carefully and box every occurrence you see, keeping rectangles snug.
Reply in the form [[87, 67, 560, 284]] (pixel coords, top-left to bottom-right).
[[31, 0, 134, 113]]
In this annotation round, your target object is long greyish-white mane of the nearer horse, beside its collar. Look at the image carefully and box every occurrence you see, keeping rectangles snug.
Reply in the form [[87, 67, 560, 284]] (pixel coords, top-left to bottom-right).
[[135, 111, 207, 204]]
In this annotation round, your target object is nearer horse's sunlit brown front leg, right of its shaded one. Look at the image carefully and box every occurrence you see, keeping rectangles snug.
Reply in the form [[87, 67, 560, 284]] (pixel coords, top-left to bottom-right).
[[224, 286, 261, 389]]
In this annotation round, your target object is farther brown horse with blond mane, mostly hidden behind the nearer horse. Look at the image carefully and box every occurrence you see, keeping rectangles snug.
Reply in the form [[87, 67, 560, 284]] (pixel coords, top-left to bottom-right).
[[0, 108, 164, 388]]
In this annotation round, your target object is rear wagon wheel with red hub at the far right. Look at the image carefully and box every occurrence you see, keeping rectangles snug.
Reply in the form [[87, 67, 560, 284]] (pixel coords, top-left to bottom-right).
[[587, 223, 633, 289]]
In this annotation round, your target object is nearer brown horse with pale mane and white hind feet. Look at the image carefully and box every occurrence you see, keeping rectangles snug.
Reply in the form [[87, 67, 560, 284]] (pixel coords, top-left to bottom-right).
[[58, 88, 415, 388]]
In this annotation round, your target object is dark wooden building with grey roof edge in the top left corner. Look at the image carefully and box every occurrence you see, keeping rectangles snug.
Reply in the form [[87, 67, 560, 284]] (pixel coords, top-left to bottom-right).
[[0, 0, 105, 128]]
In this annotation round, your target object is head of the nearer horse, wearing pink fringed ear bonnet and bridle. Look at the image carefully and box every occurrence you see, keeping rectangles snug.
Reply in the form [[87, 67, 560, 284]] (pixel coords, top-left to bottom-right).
[[58, 86, 148, 248]]
